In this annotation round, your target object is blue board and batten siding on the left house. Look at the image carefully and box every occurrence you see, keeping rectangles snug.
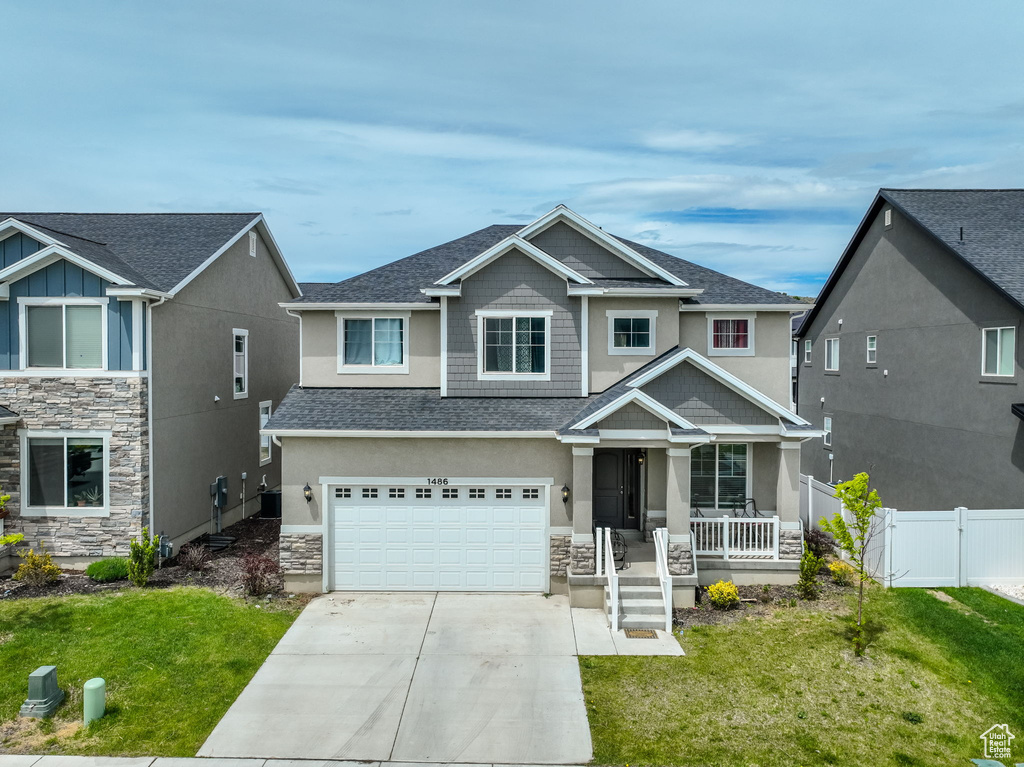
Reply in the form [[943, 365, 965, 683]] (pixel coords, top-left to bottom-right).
[[0, 260, 137, 371]]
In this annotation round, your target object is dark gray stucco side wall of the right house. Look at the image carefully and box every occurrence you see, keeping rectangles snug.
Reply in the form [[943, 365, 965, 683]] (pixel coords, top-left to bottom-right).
[[799, 206, 1024, 510]]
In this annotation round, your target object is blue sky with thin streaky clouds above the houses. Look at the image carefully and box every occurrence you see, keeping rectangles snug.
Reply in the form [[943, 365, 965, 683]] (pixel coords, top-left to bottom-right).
[[0, 0, 1024, 295]]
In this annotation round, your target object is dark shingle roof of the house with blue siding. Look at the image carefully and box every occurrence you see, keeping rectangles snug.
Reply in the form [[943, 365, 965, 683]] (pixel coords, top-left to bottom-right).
[[0, 213, 259, 292]]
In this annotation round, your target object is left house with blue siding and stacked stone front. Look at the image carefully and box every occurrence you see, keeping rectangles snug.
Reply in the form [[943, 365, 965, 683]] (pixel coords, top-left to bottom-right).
[[0, 213, 301, 566]]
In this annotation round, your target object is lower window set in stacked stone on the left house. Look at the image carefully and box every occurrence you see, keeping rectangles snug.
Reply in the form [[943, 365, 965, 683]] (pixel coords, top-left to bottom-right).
[[23, 434, 108, 513]]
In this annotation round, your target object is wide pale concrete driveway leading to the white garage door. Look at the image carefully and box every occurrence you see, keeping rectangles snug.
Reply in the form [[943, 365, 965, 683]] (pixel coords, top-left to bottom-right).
[[199, 593, 593, 764]]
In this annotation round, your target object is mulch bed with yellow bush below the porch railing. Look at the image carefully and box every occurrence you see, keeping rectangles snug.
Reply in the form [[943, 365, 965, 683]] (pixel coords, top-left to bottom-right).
[[672, 576, 854, 629]]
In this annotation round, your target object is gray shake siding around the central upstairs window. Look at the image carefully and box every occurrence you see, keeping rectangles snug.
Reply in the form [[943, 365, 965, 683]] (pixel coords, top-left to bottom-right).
[[447, 252, 583, 397]]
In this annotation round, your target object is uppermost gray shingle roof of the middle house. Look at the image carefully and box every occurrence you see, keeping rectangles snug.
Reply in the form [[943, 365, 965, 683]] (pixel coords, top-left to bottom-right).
[[296, 224, 793, 305]]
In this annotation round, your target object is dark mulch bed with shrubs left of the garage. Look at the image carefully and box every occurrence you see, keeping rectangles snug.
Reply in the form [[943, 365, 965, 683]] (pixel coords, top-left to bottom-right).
[[0, 517, 288, 600]]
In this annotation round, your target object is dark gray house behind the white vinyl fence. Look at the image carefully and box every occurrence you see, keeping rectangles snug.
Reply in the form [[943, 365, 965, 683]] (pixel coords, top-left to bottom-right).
[[798, 189, 1024, 511]]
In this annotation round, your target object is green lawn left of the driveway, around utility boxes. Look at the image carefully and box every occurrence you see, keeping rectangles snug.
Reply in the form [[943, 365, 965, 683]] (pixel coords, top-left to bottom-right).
[[0, 588, 299, 756]]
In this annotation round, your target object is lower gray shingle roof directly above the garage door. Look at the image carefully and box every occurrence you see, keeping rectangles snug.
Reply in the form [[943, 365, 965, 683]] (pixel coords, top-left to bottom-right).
[[264, 386, 588, 431]]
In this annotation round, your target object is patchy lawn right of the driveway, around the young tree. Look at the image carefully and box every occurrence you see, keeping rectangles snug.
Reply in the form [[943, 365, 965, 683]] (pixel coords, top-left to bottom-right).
[[580, 588, 1024, 767]]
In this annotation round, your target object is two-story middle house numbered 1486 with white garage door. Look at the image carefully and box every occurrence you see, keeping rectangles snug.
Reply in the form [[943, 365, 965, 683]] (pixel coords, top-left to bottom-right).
[[263, 206, 816, 604]]
